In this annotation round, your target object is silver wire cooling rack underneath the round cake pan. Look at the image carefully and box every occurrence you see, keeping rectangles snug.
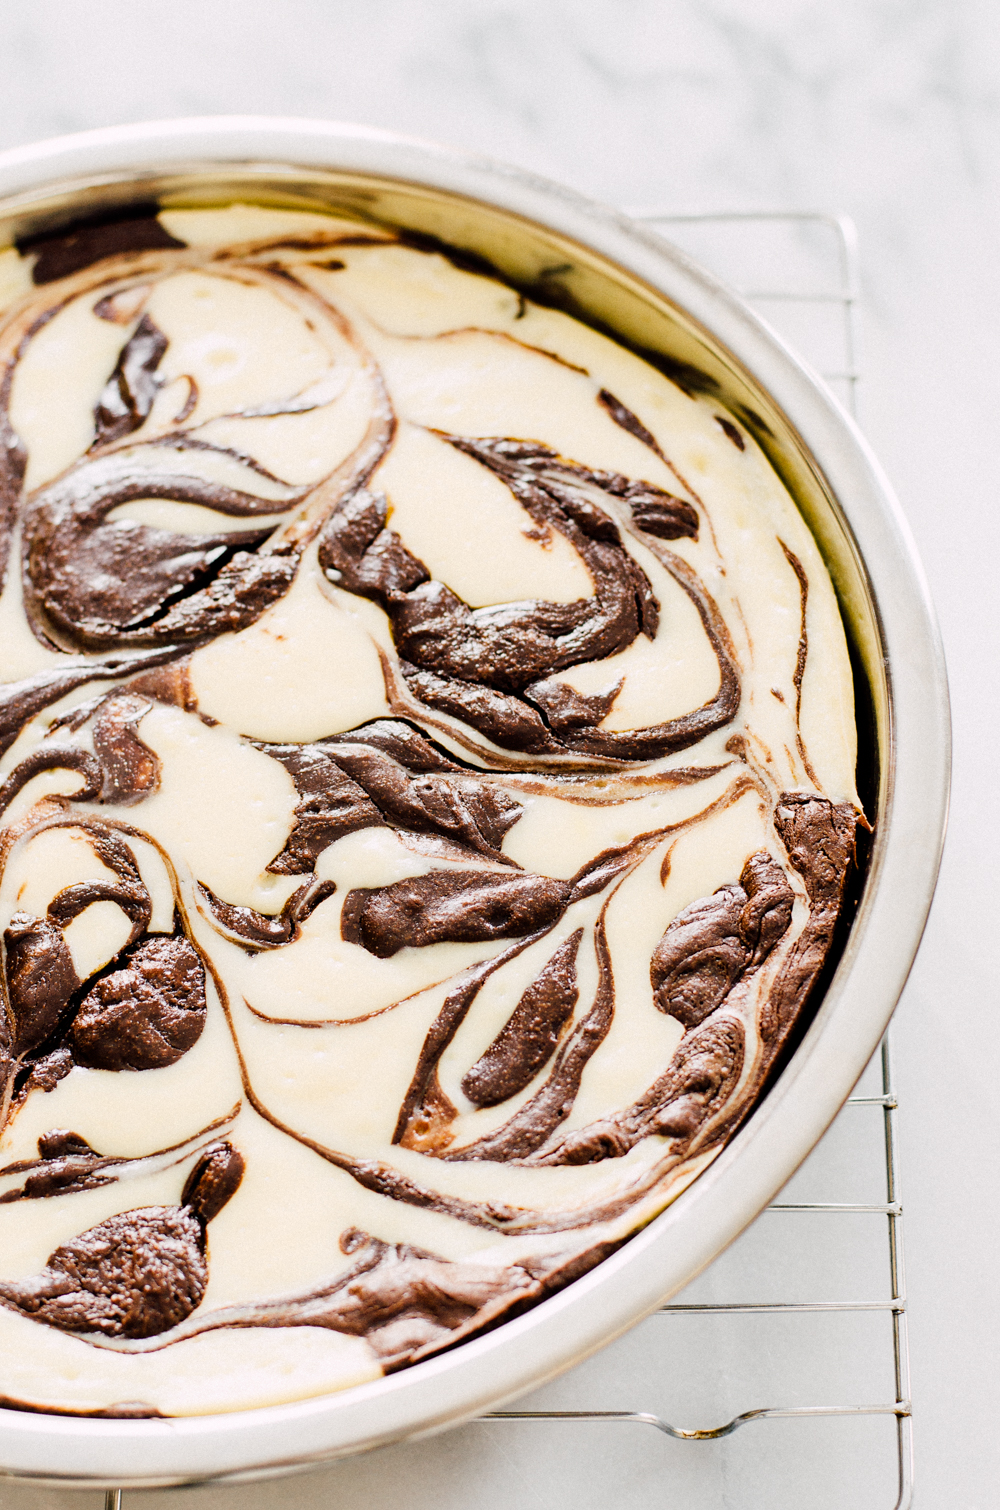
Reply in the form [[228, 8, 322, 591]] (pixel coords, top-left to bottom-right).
[[84, 210, 912, 1510]]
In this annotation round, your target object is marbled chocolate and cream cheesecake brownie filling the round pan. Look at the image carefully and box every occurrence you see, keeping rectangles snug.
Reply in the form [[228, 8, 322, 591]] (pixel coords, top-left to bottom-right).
[[0, 205, 860, 1418]]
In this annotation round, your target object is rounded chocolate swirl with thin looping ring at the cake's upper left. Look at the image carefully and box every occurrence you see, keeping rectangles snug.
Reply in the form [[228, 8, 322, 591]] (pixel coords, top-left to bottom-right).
[[0, 237, 394, 667]]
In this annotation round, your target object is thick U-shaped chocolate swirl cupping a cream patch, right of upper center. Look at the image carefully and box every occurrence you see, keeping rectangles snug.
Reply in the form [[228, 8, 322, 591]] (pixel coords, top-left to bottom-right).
[[319, 435, 739, 760]]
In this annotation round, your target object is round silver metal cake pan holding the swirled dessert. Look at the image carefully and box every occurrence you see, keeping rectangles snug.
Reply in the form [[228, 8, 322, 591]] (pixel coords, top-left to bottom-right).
[[0, 118, 949, 1487]]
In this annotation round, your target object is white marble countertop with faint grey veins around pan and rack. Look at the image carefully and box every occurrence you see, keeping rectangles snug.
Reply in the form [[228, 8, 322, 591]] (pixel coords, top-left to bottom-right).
[[0, 0, 1000, 1510]]
